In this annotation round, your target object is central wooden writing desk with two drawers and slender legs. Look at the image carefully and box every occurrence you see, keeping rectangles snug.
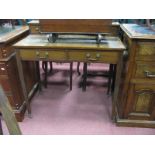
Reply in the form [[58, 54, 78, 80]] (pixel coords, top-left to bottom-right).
[[14, 34, 125, 121]]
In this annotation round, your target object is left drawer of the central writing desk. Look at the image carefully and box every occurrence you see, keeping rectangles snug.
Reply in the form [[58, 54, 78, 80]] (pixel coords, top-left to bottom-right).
[[20, 50, 67, 61]]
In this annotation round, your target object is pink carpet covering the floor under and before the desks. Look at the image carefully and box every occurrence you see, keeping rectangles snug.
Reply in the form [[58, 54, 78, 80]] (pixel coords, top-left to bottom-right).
[[3, 63, 155, 135]]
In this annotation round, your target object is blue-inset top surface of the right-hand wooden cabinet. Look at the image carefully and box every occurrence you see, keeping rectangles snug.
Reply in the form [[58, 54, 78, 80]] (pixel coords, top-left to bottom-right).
[[121, 24, 155, 39]]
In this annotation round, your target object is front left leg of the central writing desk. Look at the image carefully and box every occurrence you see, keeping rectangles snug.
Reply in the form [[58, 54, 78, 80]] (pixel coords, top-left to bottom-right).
[[16, 50, 31, 117]]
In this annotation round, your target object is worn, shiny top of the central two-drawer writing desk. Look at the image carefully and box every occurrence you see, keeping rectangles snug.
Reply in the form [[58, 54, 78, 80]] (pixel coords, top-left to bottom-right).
[[14, 34, 125, 51]]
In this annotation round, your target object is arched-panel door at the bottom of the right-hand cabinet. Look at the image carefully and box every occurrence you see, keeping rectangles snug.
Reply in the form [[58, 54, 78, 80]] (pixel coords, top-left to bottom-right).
[[124, 84, 155, 120]]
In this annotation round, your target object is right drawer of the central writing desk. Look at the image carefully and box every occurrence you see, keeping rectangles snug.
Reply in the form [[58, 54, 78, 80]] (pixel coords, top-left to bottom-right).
[[68, 51, 120, 64]]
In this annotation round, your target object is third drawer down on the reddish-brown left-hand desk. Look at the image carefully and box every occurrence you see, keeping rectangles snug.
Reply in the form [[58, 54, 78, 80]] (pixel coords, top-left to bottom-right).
[[0, 76, 11, 92]]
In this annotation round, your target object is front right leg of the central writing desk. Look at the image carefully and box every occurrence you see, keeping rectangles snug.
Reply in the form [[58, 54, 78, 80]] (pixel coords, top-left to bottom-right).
[[112, 55, 123, 122]]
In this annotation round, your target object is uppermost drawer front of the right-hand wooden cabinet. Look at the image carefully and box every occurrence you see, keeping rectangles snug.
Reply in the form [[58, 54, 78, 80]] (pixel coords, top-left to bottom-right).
[[136, 42, 155, 61]]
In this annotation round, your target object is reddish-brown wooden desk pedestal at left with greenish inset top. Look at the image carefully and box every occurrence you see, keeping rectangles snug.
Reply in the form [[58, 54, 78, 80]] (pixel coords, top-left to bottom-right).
[[0, 26, 37, 121]]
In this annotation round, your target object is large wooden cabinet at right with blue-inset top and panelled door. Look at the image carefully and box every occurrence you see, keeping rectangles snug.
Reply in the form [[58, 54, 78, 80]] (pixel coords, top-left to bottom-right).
[[116, 24, 155, 127]]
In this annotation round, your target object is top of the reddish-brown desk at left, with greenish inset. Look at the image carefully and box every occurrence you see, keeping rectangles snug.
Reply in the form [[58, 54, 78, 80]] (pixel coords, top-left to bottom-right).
[[0, 26, 29, 44]]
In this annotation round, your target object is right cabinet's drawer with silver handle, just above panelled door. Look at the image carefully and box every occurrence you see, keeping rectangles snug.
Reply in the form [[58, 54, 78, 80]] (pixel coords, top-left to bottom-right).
[[134, 61, 155, 80]]
